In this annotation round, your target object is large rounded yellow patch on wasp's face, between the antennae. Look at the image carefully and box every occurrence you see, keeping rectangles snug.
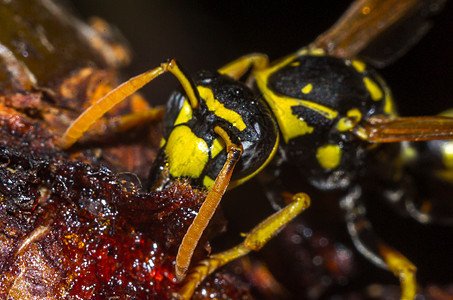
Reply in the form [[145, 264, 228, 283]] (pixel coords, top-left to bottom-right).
[[165, 126, 209, 178]]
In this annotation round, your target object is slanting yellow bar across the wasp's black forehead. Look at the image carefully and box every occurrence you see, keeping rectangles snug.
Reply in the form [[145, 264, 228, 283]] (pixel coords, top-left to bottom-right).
[[197, 86, 246, 131]]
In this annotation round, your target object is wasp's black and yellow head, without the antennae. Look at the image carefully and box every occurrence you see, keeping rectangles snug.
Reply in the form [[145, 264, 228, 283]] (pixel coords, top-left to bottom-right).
[[151, 71, 279, 190]]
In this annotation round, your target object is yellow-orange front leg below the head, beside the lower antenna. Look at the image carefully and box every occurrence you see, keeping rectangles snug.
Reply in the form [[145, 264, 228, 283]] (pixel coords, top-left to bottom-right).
[[179, 193, 310, 299]]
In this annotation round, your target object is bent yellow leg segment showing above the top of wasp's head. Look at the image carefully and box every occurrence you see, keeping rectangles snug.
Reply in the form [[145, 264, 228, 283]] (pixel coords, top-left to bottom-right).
[[217, 53, 269, 79]]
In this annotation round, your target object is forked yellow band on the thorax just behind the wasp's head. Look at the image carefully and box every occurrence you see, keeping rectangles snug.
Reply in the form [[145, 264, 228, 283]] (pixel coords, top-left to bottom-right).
[[253, 55, 338, 143]]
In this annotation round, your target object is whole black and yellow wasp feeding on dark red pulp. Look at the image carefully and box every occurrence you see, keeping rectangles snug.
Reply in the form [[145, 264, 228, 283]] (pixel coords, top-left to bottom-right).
[[59, 0, 453, 299]]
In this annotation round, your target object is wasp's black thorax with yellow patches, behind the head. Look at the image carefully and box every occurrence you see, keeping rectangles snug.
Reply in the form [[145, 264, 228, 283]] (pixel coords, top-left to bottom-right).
[[249, 49, 395, 188]]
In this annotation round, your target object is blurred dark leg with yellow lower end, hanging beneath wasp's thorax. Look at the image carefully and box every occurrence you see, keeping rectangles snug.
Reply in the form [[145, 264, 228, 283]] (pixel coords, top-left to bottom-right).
[[341, 186, 417, 300]]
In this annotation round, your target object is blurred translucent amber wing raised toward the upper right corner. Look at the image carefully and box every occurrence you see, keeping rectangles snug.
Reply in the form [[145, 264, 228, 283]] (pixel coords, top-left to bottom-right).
[[310, 0, 446, 68]]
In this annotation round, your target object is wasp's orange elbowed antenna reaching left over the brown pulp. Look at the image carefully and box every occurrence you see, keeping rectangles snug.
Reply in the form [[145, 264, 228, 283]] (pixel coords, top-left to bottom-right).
[[59, 60, 198, 149]]
